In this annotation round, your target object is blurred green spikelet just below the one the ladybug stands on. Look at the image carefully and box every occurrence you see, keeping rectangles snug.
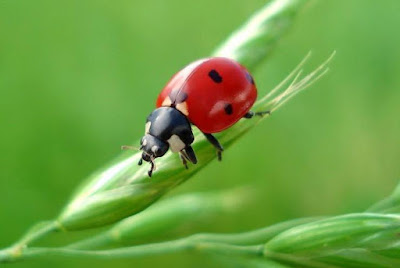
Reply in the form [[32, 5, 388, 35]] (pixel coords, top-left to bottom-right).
[[68, 188, 253, 249]]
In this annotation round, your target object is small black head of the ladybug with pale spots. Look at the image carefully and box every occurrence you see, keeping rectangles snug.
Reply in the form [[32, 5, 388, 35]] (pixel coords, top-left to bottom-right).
[[140, 134, 169, 162]]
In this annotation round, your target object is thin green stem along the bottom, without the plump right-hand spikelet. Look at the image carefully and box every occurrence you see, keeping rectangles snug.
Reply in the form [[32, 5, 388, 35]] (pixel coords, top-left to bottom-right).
[[0, 218, 320, 262]]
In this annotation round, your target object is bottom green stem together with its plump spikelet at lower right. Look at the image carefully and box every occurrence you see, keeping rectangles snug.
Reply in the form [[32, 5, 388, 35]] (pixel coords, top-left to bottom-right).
[[5, 213, 400, 268]]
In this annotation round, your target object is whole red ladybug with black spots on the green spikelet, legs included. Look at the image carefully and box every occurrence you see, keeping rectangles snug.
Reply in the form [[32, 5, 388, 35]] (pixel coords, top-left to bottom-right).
[[139, 57, 269, 177]]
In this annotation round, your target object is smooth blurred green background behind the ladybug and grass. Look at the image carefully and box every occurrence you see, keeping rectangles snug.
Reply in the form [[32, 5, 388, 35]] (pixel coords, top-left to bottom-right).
[[0, 0, 400, 268]]
